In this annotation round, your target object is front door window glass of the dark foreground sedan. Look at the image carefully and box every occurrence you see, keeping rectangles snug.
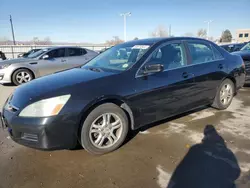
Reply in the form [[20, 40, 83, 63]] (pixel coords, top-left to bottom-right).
[[147, 43, 187, 70]]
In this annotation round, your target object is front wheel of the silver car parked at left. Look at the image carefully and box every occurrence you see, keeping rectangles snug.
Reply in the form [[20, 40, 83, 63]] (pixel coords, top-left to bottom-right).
[[12, 69, 34, 86]]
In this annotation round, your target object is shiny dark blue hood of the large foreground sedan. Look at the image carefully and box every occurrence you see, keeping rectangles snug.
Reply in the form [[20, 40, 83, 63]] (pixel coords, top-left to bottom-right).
[[8, 68, 117, 108]]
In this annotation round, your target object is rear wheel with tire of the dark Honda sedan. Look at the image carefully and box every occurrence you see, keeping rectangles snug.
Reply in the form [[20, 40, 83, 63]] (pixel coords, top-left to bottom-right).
[[212, 79, 235, 110]]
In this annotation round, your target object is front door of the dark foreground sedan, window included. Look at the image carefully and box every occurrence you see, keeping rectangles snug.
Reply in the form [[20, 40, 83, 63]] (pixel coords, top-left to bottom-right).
[[130, 42, 195, 128]]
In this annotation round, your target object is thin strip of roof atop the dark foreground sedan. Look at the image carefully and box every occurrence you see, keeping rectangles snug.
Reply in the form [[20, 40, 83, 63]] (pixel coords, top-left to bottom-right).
[[126, 37, 214, 45]]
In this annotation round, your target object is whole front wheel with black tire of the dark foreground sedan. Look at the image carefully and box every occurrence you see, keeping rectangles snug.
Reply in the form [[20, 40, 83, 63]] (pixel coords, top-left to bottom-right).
[[81, 103, 128, 155]]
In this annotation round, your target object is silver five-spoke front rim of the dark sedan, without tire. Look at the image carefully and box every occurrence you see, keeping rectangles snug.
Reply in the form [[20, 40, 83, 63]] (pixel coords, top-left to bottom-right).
[[89, 113, 123, 149]]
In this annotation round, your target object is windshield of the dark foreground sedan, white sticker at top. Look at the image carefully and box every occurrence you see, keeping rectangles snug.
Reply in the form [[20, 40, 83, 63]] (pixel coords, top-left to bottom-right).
[[82, 43, 150, 71]]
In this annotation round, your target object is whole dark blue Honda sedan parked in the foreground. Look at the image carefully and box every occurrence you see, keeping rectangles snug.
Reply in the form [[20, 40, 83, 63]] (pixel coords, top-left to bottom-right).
[[1, 37, 245, 154]]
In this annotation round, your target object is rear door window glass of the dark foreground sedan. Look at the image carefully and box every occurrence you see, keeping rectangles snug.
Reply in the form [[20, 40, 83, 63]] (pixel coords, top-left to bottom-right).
[[188, 42, 215, 64]]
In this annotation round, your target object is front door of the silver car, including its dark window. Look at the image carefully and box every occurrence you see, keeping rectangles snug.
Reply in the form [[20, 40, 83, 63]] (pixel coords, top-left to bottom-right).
[[34, 48, 67, 76]]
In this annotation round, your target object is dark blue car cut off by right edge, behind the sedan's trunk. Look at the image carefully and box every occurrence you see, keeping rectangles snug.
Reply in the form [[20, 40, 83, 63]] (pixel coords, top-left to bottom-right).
[[232, 42, 250, 83]]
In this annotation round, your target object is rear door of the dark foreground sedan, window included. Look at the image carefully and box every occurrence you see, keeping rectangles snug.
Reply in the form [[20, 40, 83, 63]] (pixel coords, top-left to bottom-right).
[[186, 40, 227, 105]]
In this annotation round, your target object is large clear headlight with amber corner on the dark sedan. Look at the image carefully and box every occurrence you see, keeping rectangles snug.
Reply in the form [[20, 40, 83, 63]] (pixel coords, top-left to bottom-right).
[[19, 95, 70, 117]]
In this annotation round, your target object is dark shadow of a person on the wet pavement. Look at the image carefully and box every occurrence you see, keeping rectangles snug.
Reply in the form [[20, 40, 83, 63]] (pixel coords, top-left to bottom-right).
[[167, 125, 241, 188]]
